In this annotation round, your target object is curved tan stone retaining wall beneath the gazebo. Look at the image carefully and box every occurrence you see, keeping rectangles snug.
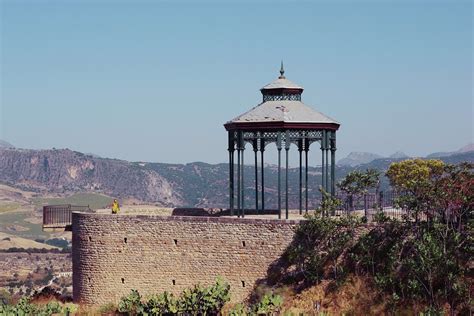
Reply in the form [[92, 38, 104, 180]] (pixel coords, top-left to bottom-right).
[[72, 213, 298, 305]]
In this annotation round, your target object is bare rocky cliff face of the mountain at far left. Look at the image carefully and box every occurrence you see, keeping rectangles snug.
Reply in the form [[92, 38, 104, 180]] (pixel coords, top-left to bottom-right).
[[0, 149, 182, 205]]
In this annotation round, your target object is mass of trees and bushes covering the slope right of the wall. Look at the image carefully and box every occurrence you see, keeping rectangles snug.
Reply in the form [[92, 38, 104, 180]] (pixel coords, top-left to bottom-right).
[[268, 159, 474, 315]]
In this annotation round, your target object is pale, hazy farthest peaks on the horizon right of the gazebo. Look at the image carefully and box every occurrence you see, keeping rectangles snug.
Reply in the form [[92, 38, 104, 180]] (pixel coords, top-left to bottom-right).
[[337, 143, 474, 167]]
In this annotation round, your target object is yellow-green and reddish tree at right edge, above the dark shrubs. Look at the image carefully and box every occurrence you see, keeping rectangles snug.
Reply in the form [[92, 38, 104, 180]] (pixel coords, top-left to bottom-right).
[[387, 159, 474, 225]]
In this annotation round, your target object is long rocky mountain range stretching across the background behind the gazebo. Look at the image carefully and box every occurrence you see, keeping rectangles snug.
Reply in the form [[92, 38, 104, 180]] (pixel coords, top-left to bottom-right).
[[0, 142, 474, 208]]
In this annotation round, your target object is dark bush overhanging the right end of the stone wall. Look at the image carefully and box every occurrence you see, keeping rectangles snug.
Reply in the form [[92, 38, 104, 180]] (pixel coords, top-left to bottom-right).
[[247, 219, 362, 304]]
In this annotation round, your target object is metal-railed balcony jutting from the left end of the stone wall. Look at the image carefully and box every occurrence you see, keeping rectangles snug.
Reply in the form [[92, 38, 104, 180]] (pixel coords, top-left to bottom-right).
[[43, 204, 90, 229]]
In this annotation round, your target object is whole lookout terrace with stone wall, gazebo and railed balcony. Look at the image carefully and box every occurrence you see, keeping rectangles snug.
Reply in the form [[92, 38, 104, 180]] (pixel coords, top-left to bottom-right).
[[43, 67, 339, 305]]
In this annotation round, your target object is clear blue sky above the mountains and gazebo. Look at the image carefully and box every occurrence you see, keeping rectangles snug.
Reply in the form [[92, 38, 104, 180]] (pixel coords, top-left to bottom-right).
[[0, 0, 474, 163]]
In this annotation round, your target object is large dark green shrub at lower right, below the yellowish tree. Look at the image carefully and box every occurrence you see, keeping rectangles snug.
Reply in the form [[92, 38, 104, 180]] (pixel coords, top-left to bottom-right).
[[348, 221, 472, 311]]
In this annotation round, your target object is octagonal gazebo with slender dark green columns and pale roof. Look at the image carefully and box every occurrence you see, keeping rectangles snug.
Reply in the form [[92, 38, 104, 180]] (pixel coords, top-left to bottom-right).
[[224, 62, 340, 219]]
